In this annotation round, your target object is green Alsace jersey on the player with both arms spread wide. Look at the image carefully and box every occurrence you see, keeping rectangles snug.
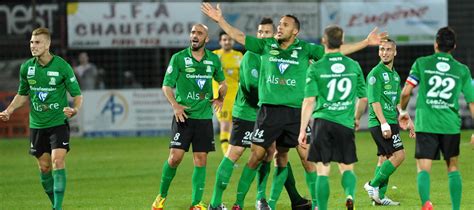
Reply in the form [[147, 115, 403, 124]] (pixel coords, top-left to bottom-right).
[[245, 36, 324, 108]]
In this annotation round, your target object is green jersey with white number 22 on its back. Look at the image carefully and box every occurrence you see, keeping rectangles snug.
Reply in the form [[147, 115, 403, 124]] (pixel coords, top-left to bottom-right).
[[407, 52, 474, 134]]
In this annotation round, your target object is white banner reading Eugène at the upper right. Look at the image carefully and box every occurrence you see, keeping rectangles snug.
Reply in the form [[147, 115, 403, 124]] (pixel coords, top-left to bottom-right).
[[321, 0, 448, 44]]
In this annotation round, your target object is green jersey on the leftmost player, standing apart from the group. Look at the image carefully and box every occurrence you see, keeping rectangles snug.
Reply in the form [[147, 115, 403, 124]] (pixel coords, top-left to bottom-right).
[[18, 55, 81, 129]]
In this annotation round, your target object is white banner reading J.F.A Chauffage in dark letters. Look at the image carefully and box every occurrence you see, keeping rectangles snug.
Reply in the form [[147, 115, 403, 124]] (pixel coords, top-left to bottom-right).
[[67, 2, 202, 49]]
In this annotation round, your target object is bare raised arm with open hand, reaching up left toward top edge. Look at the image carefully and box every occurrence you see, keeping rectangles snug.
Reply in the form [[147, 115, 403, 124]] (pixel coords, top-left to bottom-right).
[[201, 2, 245, 46]]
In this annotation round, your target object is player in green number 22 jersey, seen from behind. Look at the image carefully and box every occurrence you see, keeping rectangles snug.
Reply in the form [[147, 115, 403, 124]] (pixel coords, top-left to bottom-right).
[[400, 27, 474, 210]]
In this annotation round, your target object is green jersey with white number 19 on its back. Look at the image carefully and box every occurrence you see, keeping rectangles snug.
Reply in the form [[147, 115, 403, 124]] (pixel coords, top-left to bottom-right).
[[305, 53, 366, 128]]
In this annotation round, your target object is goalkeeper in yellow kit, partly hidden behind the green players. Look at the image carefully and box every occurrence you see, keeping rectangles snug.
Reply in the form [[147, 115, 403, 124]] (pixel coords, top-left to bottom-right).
[[213, 32, 243, 154]]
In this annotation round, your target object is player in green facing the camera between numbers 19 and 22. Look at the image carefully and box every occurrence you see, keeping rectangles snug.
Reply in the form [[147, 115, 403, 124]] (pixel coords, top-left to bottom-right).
[[364, 39, 412, 206]]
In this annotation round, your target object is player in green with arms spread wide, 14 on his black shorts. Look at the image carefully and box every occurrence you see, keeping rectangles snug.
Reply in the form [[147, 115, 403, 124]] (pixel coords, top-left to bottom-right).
[[201, 3, 386, 209]]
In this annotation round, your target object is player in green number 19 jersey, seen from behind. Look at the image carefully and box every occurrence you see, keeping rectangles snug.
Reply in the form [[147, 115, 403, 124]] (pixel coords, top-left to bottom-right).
[[298, 26, 367, 210]]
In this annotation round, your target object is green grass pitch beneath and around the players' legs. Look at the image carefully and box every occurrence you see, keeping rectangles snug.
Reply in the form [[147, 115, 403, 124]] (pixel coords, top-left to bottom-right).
[[0, 131, 474, 210]]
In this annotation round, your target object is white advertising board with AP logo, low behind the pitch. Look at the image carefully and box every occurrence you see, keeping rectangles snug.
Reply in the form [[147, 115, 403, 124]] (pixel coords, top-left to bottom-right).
[[81, 89, 173, 137]]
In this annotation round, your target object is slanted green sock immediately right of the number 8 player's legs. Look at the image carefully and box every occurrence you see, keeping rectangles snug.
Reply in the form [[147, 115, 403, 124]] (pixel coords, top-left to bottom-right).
[[211, 157, 234, 207]]
